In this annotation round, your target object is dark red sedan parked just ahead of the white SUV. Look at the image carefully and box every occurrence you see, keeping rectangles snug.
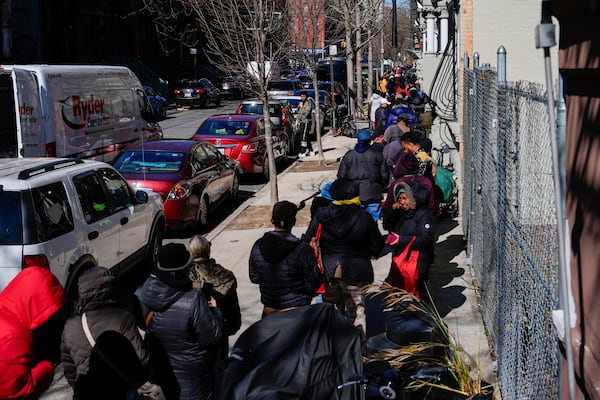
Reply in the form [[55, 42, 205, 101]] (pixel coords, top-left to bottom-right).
[[113, 140, 241, 230]]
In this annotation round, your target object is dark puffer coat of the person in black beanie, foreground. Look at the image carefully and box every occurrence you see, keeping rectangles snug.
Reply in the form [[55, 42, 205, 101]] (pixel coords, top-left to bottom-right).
[[140, 275, 223, 400]]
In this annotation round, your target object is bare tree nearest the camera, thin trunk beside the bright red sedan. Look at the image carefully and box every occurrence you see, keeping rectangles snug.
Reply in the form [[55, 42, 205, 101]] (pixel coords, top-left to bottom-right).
[[186, 0, 289, 204]]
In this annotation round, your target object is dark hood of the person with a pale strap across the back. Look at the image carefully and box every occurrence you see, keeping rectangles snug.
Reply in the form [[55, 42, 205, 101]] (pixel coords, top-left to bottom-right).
[[77, 267, 119, 312]]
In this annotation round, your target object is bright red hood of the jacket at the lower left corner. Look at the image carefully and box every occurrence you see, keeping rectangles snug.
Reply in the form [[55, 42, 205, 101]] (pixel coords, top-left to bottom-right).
[[0, 267, 66, 330]]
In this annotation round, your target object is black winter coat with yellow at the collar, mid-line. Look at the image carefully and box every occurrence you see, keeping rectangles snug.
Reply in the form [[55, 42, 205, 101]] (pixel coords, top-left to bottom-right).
[[303, 201, 384, 284]]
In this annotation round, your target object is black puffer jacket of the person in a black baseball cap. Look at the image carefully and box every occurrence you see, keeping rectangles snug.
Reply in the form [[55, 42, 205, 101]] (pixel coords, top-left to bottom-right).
[[249, 231, 323, 309]]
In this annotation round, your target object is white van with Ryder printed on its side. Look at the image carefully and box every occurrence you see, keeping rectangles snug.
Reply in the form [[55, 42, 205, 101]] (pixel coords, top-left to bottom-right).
[[0, 65, 162, 161]]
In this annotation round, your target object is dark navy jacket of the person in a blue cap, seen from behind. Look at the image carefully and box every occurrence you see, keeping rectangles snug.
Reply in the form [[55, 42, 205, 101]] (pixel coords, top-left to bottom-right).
[[337, 145, 389, 204]]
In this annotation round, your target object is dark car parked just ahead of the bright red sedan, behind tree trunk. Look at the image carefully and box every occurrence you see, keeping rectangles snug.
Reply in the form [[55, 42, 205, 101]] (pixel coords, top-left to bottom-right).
[[236, 99, 300, 154]]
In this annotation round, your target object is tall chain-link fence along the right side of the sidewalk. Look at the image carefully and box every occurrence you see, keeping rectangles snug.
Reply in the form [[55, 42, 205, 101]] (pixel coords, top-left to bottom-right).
[[462, 66, 559, 400]]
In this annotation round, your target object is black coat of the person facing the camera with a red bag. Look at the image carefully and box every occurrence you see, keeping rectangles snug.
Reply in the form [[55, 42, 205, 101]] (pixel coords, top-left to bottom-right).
[[384, 181, 435, 281]]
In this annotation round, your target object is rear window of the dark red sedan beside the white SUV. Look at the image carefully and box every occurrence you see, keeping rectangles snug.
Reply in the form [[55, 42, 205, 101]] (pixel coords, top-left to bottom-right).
[[113, 150, 185, 174]]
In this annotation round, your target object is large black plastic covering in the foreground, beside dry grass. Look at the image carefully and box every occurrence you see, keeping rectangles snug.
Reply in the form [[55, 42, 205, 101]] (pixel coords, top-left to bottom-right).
[[219, 303, 362, 400]]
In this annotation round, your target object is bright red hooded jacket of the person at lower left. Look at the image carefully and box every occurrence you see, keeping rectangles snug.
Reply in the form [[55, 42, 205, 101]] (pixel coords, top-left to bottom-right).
[[0, 267, 65, 399]]
